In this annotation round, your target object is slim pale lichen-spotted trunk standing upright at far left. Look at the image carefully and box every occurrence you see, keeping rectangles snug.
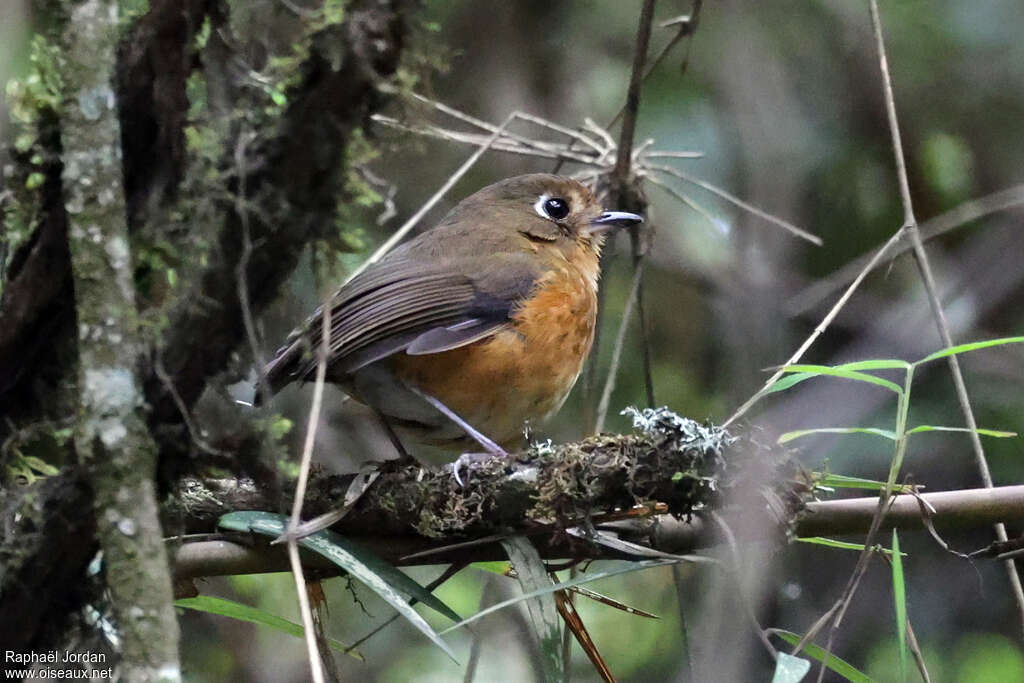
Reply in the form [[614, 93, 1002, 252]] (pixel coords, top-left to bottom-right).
[[61, 0, 181, 681]]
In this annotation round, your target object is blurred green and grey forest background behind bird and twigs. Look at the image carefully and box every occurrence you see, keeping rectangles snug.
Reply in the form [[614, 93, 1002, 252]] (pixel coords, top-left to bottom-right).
[[8, 0, 1024, 682]]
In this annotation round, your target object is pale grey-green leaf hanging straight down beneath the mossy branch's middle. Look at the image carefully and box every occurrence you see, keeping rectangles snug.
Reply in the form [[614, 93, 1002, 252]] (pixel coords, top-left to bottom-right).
[[502, 536, 565, 683]]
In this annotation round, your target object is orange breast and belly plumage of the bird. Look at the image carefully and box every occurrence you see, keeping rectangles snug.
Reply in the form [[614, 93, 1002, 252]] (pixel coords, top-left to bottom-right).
[[392, 258, 597, 445]]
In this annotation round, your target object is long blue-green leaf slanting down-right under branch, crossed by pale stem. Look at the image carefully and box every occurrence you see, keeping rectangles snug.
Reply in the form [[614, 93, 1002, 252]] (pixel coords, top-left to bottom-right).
[[218, 511, 459, 660]]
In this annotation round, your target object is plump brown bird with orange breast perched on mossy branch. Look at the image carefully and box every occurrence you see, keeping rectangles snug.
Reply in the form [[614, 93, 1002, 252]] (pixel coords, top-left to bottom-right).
[[265, 174, 643, 478]]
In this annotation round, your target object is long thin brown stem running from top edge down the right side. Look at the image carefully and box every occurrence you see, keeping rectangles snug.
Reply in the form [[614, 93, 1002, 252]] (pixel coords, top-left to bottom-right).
[[870, 0, 1024, 628]]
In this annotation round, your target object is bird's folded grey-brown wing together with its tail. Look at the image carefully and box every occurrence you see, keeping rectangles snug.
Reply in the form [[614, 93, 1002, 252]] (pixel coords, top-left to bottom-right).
[[260, 253, 540, 391]]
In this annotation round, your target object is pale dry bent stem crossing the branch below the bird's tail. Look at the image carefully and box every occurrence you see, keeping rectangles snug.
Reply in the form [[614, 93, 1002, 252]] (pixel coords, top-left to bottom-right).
[[288, 301, 331, 683]]
